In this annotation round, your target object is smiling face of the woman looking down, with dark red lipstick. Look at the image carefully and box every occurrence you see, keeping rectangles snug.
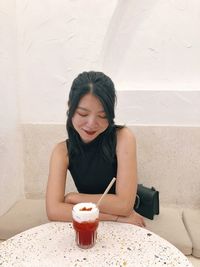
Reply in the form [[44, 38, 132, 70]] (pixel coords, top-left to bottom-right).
[[72, 93, 108, 143]]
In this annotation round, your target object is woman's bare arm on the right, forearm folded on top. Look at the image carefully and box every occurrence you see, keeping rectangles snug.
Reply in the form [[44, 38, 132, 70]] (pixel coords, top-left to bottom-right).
[[65, 128, 137, 219]]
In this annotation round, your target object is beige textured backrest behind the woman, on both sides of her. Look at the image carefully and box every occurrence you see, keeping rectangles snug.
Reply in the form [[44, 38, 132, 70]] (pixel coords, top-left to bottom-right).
[[23, 124, 200, 208]]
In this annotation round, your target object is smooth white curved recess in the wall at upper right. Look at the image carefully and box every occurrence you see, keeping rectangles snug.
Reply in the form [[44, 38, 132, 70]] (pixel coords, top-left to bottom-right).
[[103, 0, 200, 90]]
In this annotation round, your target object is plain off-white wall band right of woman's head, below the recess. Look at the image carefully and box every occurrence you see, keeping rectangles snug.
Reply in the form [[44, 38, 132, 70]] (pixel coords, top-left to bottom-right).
[[116, 91, 200, 126]]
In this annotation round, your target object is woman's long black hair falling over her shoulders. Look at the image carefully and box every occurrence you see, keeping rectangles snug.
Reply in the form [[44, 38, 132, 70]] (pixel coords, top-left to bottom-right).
[[66, 71, 123, 161]]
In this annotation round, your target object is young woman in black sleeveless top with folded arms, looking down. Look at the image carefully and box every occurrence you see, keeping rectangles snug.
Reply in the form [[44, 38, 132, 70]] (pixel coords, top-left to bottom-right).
[[46, 71, 145, 227]]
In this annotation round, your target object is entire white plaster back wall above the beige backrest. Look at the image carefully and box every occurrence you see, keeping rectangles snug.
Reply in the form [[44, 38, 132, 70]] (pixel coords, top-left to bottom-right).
[[16, 0, 200, 125]]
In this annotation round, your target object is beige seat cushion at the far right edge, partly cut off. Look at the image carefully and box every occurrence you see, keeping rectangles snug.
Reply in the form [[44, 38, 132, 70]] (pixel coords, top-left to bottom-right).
[[183, 209, 200, 258]]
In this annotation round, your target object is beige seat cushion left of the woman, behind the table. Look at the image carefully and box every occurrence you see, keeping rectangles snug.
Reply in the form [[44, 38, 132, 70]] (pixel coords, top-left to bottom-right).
[[0, 199, 48, 240]]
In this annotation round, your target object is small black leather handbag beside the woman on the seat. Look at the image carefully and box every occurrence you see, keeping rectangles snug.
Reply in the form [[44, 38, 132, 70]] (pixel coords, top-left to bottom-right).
[[134, 184, 159, 220]]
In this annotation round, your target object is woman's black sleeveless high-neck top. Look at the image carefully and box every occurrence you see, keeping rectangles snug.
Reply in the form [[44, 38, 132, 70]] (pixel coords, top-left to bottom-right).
[[66, 133, 117, 194]]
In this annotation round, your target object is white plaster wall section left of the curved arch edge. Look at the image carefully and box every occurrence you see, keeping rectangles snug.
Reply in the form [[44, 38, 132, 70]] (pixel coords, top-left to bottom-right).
[[17, 0, 117, 123]]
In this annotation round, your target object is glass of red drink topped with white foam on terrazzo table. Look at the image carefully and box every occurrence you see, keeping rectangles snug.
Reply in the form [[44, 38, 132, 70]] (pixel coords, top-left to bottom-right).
[[72, 203, 99, 249]]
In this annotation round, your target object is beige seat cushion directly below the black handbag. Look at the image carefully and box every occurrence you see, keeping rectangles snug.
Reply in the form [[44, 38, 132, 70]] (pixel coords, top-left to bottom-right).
[[145, 207, 192, 255]]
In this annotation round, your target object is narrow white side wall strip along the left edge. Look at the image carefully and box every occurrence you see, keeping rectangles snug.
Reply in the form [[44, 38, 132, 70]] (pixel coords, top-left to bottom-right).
[[0, 0, 24, 215]]
